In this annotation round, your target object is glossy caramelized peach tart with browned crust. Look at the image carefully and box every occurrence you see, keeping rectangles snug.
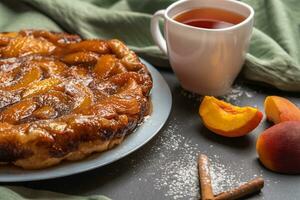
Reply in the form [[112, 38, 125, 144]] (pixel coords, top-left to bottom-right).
[[0, 30, 152, 169]]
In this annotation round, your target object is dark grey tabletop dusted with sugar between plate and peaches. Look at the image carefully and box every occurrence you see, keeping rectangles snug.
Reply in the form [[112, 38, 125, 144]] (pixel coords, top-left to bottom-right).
[[3, 70, 300, 200]]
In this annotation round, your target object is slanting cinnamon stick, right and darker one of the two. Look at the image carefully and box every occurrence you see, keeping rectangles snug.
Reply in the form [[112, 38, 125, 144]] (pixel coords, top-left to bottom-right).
[[214, 178, 264, 200]]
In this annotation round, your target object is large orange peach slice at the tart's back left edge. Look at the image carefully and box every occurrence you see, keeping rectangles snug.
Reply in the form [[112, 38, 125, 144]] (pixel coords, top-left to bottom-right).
[[2, 36, 56, 58]]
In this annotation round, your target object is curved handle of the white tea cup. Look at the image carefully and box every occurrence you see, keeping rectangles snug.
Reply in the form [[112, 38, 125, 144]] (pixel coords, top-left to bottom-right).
[[151, 10, 168, 55]]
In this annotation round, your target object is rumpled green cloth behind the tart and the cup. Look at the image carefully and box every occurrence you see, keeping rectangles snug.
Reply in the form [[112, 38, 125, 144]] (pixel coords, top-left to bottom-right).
[[0, 0, 300, 91]]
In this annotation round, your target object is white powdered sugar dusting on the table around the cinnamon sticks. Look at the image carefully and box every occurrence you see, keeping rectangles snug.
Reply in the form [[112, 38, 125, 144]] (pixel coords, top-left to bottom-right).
[[130, 119, 247, 200]]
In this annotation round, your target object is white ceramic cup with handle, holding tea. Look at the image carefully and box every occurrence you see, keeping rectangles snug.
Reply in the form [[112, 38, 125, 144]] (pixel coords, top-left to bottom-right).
[[151, 0, 254, 96]]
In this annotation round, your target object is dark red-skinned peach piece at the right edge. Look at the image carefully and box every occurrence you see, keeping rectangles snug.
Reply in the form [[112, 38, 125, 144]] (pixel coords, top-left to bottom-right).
[[256, 121, 300, 173]]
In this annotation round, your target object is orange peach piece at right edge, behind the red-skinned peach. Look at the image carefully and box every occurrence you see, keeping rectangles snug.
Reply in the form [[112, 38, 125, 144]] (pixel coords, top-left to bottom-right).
[[264, 96, 300, 124]]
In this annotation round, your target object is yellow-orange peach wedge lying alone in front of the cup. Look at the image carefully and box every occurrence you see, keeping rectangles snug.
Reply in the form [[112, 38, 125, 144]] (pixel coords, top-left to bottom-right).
[[199, 96, 263, 137]]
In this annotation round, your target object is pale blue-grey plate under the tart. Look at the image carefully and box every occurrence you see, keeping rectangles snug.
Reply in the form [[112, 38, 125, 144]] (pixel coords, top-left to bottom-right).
[[0, 60, 172, 182]]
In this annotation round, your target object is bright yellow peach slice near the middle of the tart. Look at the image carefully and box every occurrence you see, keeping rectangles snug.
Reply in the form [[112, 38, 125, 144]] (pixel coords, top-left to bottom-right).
[[22, 78, 61, 98]]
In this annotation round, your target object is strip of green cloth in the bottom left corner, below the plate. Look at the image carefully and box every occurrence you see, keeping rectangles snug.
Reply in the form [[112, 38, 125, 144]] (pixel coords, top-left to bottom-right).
[[0, 186, 110, 200]]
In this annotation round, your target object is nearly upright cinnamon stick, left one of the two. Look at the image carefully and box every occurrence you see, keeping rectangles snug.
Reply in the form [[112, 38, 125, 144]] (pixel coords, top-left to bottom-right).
[[198, 154, 214, 200]]
